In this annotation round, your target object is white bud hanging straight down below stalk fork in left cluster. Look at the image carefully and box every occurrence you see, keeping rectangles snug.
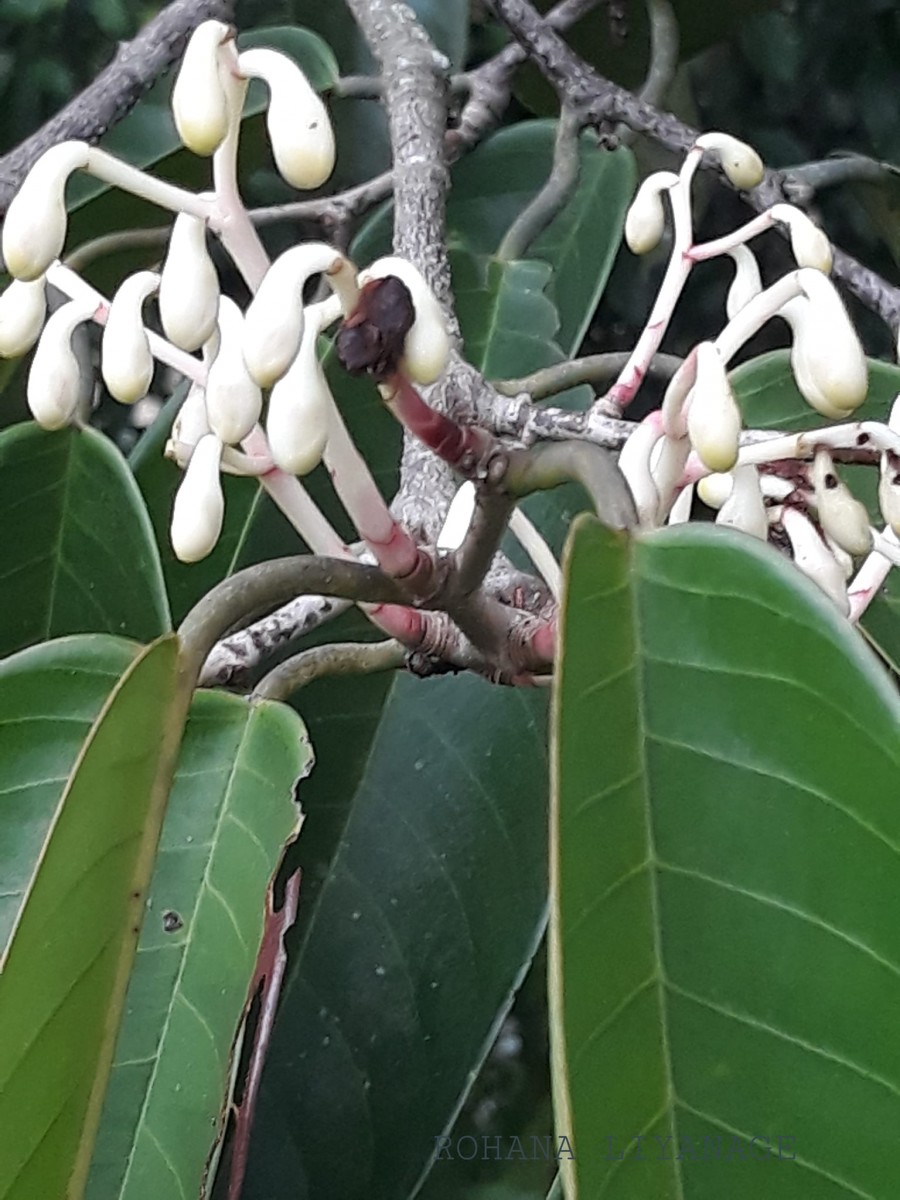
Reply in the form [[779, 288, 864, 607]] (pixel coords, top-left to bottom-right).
[[160, 212, 218, 352]]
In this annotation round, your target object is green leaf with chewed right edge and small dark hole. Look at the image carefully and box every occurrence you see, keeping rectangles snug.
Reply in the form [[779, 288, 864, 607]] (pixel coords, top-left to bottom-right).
[[86, 692, 311, 1200]]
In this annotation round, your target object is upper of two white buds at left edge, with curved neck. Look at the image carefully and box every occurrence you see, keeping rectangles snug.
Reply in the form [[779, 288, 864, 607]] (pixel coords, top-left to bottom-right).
[[2, 142, 90, 280]]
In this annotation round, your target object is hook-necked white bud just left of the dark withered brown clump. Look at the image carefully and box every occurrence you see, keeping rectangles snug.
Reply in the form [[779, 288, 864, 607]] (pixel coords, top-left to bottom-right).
[[242, 241, 358, 388]]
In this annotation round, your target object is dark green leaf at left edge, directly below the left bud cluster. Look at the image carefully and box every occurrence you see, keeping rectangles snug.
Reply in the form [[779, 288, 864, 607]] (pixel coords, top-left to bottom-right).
[[0, 424, 169, 655]]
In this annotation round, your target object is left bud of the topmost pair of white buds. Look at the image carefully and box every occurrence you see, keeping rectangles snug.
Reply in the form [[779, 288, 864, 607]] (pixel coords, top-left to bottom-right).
[[172, 20, 236, 156]]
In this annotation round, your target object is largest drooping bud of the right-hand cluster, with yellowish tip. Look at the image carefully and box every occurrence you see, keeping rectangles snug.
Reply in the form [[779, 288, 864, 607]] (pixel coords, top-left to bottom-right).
[[779, 268, 869, 421]]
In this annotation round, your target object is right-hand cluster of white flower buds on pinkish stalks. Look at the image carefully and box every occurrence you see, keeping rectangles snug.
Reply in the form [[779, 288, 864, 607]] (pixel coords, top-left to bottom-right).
[[619, 133, 900, 612]]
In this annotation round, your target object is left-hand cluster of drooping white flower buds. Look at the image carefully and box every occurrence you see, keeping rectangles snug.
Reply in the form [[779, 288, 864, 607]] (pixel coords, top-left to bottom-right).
[[0, 20, 449, 562]]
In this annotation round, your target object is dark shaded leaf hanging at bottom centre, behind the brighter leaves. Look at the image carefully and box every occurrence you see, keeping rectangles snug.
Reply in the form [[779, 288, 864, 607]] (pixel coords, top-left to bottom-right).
[[244, 676, 546, 1200]]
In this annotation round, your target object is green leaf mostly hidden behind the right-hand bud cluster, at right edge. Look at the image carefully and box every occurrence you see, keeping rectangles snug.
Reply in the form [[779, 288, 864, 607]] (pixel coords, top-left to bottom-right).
[[731, 350, 900, 686]]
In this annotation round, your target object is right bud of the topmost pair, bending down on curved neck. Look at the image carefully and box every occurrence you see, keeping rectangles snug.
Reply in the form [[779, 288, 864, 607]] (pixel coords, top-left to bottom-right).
[[238, 49, 335, 191]]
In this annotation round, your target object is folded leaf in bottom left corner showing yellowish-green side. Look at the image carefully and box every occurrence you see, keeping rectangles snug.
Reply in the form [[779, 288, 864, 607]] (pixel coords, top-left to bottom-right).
[[0, 635, 182, 1200]]
